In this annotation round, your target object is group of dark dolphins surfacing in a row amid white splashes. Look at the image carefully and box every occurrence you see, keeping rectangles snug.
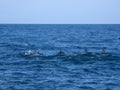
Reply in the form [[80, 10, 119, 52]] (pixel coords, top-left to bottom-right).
[[24, 47, 110, 56]]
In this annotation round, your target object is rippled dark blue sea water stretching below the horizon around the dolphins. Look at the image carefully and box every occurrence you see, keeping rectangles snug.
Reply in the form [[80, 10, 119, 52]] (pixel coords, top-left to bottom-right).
[[0, 25, 120, 90]]
